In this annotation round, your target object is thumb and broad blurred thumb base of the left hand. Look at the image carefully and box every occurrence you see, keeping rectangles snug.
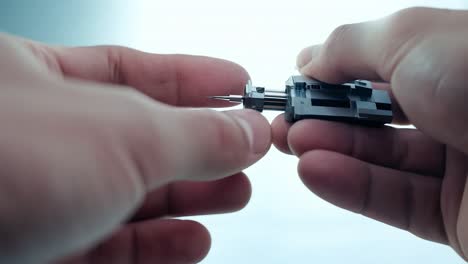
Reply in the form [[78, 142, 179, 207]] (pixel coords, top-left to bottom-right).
[[0, 81, 271, 263]]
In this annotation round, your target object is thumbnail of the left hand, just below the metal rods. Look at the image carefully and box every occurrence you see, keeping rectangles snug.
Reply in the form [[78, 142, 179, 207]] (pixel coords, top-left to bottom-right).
[[225, 109, 271, 154]]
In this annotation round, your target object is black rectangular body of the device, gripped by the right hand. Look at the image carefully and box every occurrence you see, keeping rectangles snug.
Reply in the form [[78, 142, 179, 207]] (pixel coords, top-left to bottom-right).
[[285, 76, 393, 126]]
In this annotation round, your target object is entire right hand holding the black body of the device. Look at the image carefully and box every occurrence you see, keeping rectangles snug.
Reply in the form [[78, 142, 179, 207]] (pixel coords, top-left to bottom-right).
[[272, 8, 468, 259]]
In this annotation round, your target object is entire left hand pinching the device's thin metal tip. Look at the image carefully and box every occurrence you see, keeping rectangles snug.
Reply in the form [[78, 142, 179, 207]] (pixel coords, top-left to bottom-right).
[[0, 35, 271, 263]]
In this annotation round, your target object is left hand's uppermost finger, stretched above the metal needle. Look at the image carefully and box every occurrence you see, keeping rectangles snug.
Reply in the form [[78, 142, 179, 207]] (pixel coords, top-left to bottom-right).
[[37, 44, 249, 107]]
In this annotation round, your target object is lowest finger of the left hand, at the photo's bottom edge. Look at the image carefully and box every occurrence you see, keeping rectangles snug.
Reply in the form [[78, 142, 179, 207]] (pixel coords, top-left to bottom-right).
[[83, 219, 211, 263]]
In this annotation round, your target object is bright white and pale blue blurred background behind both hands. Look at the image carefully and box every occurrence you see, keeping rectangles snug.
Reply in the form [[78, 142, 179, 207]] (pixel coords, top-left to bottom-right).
[[0, 0, 468, 264]]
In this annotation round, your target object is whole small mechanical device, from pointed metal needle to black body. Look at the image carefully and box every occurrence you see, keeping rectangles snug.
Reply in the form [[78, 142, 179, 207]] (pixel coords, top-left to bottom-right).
[[211, 76, 393, 126]]
